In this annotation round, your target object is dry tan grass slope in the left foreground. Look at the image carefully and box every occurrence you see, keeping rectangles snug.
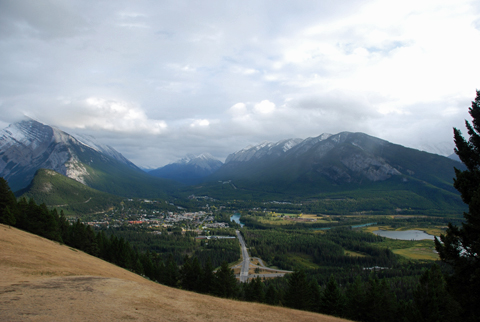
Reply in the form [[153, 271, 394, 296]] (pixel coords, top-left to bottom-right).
[[0, 225, 346, 322]]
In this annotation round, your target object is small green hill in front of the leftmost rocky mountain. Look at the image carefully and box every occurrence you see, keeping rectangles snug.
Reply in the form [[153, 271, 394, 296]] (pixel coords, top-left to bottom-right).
[[17, 169, 122, 215]]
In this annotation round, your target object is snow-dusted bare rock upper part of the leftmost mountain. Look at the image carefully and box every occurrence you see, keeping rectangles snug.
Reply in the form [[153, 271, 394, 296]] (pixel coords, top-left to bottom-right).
[[0, 119, 138, 190]]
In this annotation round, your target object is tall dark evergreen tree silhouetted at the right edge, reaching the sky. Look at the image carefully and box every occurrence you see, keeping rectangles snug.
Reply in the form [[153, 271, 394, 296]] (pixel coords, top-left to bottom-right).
[[435, 90, 480, 321]]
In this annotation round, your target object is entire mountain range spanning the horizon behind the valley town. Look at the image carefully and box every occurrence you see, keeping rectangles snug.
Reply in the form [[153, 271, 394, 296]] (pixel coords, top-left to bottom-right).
[[0, 120, 463, 213]]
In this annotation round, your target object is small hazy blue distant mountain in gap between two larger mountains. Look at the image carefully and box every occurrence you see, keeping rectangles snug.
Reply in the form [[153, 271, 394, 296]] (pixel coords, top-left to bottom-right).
[[148, 153, 223, 184]]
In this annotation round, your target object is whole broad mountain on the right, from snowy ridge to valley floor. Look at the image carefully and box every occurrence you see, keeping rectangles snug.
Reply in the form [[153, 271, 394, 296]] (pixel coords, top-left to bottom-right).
[[197, 132, 465, 214]]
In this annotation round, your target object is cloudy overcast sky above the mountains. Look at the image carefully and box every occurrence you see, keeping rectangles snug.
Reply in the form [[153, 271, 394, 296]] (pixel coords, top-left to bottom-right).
[[0, 0, 480, 167]]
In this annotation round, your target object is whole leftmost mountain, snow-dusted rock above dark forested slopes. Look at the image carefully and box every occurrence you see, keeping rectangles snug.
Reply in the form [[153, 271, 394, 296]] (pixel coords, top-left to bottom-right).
[[0, 119, 177, 195]]
